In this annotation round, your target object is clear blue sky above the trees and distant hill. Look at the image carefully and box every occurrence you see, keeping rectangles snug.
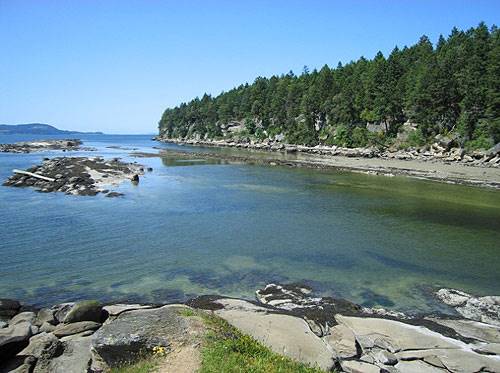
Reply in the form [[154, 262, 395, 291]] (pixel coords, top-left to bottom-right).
[[0, 0, 500, 133]]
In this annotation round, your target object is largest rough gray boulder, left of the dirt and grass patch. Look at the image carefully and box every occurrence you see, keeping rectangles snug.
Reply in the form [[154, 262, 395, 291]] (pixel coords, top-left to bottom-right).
[[92, 305, 194, 367]]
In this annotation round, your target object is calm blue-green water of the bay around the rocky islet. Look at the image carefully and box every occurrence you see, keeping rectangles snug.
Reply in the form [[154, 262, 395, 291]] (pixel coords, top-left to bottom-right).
[[0, 135, 500, 311]]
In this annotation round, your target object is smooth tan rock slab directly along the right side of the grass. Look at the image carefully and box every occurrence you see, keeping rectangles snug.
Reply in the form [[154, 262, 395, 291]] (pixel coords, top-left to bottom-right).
[[215, 299, 335, 370]]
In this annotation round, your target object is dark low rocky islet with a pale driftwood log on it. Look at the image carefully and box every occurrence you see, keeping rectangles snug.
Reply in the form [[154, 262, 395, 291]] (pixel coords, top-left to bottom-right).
[[3, 157, 144, 197]]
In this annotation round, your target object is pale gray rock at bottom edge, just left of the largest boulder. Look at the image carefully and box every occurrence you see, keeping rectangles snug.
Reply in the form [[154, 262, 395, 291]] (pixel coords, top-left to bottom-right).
[[33, 337, 92, 373]]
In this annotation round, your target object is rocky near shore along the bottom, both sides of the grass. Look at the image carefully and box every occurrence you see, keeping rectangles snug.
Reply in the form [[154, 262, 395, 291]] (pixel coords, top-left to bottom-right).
[[0, 284, 500, 373]]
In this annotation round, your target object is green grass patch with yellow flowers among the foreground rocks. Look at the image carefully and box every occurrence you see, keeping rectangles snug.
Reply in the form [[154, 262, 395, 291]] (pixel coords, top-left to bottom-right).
[[200, 314, 322, 373]]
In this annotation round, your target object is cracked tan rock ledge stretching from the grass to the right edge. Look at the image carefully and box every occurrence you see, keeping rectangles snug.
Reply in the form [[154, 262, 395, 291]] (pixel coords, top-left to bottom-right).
[[216, 284, 500, 373]]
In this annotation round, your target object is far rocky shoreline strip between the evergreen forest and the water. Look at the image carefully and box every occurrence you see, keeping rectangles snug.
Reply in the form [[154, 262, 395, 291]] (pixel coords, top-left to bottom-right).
[[154, 136, 500, 189]]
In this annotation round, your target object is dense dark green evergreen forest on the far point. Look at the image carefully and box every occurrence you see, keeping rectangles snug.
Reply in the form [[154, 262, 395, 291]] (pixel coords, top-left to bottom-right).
[[159, 23, 500, 149]]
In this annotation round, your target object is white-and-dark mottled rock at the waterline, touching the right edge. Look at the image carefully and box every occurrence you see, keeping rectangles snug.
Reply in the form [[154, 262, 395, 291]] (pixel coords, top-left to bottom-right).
[[436, 289, 500, 326]]
